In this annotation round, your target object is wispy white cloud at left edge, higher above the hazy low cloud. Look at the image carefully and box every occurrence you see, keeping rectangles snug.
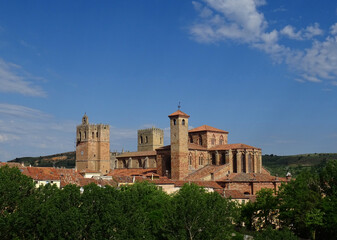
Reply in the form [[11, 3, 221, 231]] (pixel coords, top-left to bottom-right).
[[0, 58, 46, 97]]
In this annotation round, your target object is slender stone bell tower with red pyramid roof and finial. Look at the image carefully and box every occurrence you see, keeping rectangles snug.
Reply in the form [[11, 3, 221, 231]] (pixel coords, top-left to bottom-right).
[[168, 107, 190, 180]]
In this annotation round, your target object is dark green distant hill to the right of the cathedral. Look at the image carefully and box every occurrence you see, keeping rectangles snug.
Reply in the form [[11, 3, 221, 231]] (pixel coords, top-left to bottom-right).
[[262, 153, 337, 177]]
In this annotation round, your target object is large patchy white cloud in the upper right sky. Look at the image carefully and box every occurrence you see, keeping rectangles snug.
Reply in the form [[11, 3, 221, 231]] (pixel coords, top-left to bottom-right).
[[190, 0, 337, 84]]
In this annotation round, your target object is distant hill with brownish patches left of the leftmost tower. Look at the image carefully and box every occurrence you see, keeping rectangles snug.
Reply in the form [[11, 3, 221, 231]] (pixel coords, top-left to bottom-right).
[[9, 152, 76, 168]]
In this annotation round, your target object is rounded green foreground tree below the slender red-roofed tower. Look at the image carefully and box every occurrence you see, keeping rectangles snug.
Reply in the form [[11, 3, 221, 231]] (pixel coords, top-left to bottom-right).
[[164, 184, 238, 240]]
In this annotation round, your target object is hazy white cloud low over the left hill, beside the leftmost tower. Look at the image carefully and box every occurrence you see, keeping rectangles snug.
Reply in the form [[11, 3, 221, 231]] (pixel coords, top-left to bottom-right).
[[0, 103, 76, 161]]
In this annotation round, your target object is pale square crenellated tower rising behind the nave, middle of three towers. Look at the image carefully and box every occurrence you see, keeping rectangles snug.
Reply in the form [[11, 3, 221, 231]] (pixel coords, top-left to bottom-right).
[[137, 127, 164, 152]]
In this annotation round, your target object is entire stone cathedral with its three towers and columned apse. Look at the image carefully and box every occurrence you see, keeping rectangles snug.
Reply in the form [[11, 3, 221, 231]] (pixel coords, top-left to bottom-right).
[[76, 109, 265, 181]]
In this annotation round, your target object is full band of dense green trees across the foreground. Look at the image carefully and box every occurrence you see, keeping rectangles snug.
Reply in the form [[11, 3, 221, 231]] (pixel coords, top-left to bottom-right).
[[0, 161, 337, 240]]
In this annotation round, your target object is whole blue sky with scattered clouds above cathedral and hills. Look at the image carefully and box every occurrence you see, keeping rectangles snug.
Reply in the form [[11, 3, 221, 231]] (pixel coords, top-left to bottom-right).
[[0, 0, 337, 161]]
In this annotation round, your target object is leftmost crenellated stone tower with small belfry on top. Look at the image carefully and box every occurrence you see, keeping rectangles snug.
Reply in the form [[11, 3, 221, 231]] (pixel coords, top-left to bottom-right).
[[76, 114, 110, 174]]
